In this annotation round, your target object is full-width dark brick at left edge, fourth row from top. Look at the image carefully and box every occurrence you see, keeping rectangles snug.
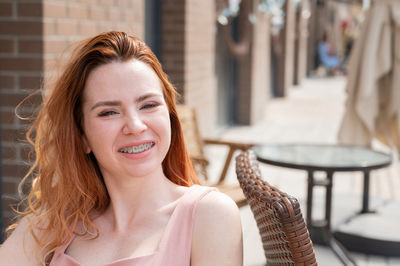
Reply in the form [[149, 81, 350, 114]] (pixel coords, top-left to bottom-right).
[[0, 57, 43, 71]]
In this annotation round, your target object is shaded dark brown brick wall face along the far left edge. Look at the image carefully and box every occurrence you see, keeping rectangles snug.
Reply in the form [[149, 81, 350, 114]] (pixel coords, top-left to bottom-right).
[[0, 1, 43, 229]]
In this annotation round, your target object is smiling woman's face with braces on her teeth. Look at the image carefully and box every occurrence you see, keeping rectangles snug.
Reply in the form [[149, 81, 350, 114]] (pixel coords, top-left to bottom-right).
[[83, 60, 171, 179]]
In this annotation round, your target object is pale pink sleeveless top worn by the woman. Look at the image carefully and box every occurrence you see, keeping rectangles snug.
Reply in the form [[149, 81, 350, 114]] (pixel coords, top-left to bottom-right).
[[50, 185, 216, 266]]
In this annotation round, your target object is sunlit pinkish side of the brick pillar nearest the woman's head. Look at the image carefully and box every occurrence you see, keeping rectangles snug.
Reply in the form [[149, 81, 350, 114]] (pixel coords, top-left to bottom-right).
[[184, 0, 217, 136]]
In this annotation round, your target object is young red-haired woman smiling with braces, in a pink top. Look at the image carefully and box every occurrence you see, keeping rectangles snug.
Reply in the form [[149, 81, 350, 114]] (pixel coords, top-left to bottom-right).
[[0, 32, 242, 266]]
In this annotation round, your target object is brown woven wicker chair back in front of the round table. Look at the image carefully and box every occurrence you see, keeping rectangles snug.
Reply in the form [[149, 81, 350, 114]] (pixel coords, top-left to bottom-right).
[[236, 151, 317, 265]]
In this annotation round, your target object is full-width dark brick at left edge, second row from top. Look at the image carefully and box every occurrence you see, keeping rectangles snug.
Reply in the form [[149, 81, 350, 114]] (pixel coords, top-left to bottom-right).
[[0, 21, 42, 37]]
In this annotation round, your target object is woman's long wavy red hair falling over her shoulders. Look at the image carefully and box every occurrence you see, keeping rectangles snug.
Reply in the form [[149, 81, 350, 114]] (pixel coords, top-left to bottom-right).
[[12, 31, 198, 265]]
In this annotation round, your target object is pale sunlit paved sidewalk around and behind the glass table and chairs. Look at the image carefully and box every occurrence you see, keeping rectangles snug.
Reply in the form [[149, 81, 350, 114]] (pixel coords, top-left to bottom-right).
[[206, 77, 400, 266]]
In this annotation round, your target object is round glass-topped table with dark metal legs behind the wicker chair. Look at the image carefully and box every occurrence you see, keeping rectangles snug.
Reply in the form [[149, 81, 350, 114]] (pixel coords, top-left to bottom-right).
[[252, 144, 392, 265]]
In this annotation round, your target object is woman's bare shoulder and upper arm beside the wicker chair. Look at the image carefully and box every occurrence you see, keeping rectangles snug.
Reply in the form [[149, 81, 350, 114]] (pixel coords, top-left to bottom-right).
[[191, 189, 243, 266]]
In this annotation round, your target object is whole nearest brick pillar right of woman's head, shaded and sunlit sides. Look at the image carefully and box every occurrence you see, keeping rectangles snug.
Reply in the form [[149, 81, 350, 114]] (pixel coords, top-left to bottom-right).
[[162, 0, 216, 135]]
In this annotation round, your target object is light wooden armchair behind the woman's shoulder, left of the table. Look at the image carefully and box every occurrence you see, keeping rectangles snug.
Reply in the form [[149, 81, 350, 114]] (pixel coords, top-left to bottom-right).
[[177, 105, 253, 207]]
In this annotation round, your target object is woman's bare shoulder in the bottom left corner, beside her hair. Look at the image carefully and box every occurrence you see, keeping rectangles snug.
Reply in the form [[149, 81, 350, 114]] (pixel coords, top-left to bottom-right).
[[0, 217, 39, 266]]
